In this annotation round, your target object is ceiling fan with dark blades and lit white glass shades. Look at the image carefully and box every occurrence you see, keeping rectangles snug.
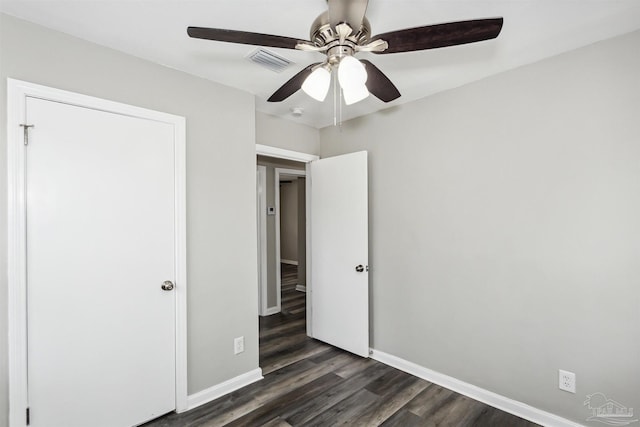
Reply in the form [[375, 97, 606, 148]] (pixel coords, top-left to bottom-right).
[[187, 0, 503, 105]]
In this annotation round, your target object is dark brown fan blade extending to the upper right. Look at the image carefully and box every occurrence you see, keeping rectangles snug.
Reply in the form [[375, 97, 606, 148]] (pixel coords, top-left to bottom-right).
[[371, 18, 503, 54]]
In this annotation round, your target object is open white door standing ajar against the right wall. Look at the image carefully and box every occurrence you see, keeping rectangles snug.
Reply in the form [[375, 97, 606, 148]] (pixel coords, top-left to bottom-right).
[[310, 151, 369, 357]]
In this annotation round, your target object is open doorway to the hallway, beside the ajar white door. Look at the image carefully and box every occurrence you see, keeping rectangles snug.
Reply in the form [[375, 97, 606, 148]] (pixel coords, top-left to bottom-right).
[[257, 146, 317, 375]]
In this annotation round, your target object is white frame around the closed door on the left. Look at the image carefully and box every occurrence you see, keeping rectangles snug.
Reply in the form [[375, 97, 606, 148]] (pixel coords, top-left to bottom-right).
[[7, 79, 187, 427]]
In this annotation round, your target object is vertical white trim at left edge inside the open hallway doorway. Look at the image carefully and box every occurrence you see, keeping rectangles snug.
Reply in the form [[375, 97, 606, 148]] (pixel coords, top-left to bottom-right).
[[256, 165, 268, 316]]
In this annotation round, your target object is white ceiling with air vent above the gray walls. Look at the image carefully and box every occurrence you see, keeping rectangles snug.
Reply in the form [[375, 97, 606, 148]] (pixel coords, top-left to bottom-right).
[[0, 0, 640, 128]]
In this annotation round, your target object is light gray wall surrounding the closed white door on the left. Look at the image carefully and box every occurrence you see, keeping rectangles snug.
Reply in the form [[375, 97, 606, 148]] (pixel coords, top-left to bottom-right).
[[0, 15, 258, 426]]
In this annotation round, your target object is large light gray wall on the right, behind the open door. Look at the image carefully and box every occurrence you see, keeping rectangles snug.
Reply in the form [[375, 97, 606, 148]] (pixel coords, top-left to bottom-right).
[[321, 32, 640, 423]]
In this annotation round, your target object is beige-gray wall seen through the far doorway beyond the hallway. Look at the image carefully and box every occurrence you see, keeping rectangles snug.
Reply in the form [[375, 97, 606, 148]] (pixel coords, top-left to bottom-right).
[[280, 178, 298, 261]]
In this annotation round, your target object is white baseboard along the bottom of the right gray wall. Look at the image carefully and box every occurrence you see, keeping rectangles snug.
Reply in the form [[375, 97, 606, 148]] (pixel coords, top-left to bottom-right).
[[371, 349, 584, 427]]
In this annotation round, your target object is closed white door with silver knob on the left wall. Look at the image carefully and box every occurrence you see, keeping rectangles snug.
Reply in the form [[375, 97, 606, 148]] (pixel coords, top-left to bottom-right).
[[26, 98, 176, 427]]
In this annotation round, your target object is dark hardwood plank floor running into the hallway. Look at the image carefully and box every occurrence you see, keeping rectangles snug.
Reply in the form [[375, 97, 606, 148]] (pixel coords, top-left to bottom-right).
[[145, 265, 537, 427]]
